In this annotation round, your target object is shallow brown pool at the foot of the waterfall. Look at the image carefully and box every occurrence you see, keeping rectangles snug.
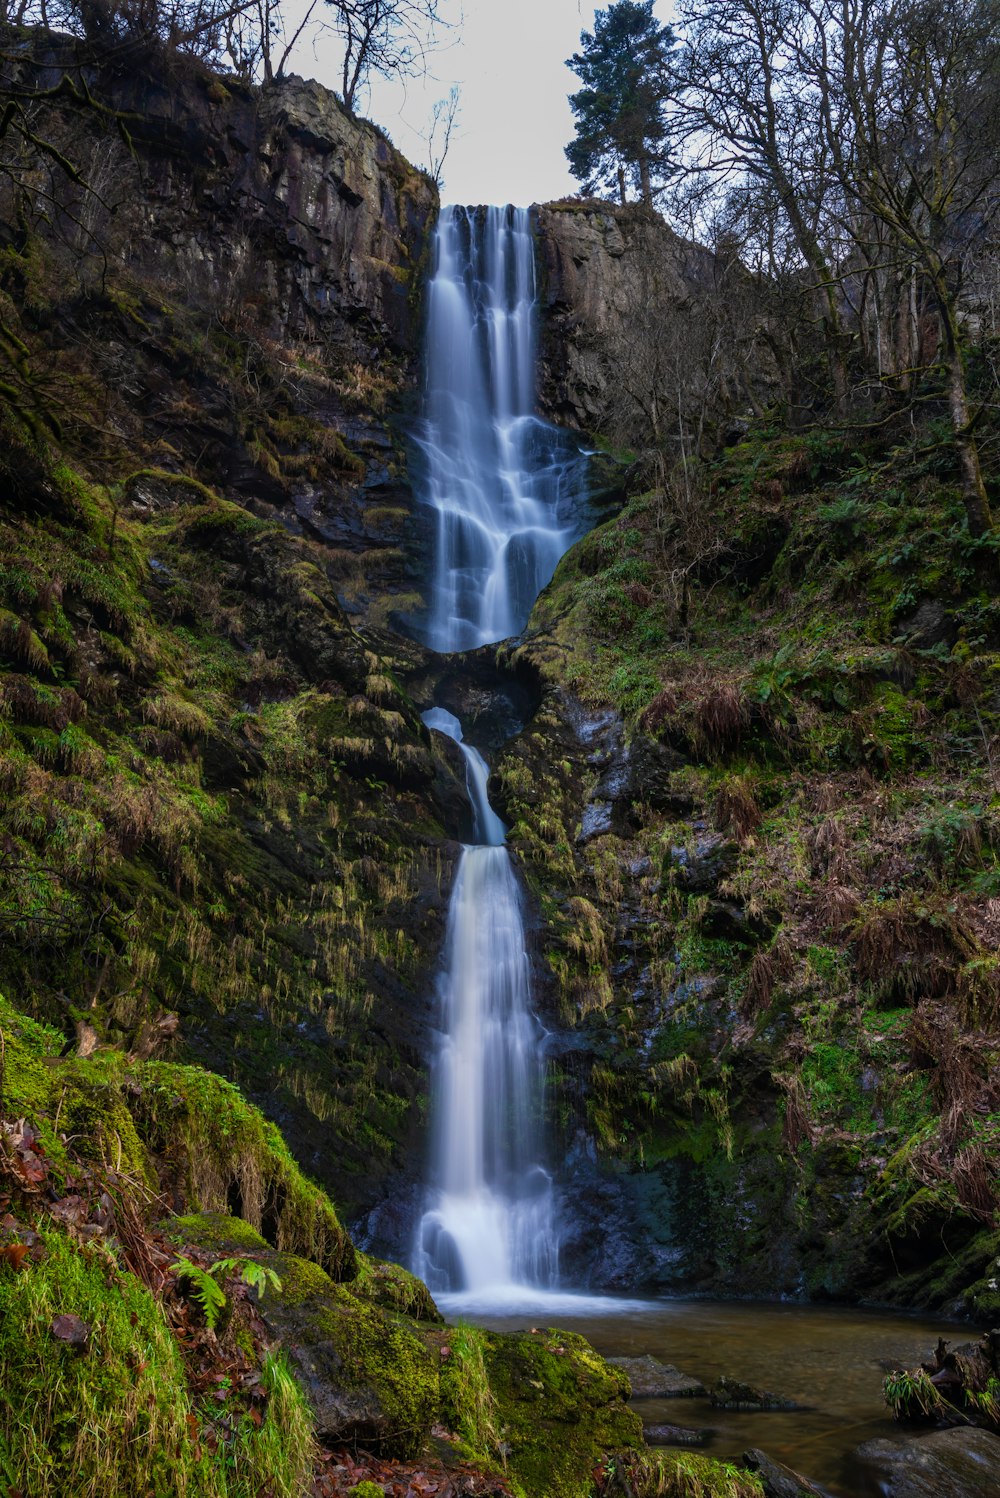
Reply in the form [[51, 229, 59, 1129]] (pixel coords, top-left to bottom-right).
[[463, 1296, 976, 1498]]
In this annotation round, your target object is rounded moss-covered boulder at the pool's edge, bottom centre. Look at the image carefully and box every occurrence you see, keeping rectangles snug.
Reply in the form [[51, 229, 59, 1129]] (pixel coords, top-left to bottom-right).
[[442, 1327, 642, 1498]]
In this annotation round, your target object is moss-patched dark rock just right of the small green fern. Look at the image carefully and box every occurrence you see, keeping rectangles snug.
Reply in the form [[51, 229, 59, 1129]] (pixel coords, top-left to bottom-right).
[[254, 1254, 439, 1459]]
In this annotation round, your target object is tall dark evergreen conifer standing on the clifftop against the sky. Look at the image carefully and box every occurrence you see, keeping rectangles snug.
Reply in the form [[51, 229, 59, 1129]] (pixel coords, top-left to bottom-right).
[[566, 0, 674, 205]]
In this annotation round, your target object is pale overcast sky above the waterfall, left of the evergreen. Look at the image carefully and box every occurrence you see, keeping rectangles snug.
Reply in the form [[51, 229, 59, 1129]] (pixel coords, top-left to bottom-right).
[[289, 0, 671, 205]]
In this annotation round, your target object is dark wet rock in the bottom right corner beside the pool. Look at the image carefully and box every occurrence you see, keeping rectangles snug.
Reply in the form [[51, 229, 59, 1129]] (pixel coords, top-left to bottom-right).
[[855, 1429, 1000, 1498]]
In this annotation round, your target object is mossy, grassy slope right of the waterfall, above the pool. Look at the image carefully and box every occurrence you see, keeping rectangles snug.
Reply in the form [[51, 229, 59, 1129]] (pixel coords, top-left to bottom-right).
[[494, 430, 1000, 1317]]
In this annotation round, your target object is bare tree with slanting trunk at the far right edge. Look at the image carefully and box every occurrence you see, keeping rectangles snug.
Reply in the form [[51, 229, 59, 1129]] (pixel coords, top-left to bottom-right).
[[811, 0, 1000, 535]]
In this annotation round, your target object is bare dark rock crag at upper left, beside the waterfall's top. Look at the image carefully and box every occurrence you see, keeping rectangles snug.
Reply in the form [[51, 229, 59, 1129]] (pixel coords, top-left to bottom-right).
[[7, 37, 437, 363]]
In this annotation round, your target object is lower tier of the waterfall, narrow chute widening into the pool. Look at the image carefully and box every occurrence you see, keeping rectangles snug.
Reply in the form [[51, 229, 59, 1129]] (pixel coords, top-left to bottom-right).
[[415, 707, 558, 1299]]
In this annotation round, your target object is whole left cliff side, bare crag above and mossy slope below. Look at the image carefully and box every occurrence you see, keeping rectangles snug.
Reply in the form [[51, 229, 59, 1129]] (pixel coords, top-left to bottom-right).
[[0, 37, 464, 1228]]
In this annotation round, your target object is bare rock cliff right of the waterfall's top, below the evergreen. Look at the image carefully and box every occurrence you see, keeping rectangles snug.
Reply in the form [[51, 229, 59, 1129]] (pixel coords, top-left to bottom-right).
[[537, 202, 717, 430]]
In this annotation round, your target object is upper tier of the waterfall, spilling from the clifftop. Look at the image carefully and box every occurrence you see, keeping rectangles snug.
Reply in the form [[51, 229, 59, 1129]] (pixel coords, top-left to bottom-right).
[[418, 208, 581, 652]]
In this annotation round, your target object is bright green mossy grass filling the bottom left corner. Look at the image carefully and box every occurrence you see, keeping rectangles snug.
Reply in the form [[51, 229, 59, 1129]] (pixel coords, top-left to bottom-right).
[[0, 1230, 314, 1498]]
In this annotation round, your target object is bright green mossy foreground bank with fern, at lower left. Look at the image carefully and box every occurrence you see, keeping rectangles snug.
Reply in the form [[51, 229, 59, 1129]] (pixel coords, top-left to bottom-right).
[[0, 1001, 655, 1498]]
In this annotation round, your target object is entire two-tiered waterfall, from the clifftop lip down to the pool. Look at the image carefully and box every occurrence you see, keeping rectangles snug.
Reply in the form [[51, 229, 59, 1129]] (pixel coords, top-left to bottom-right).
[[413, 208, 585, 1305]]
